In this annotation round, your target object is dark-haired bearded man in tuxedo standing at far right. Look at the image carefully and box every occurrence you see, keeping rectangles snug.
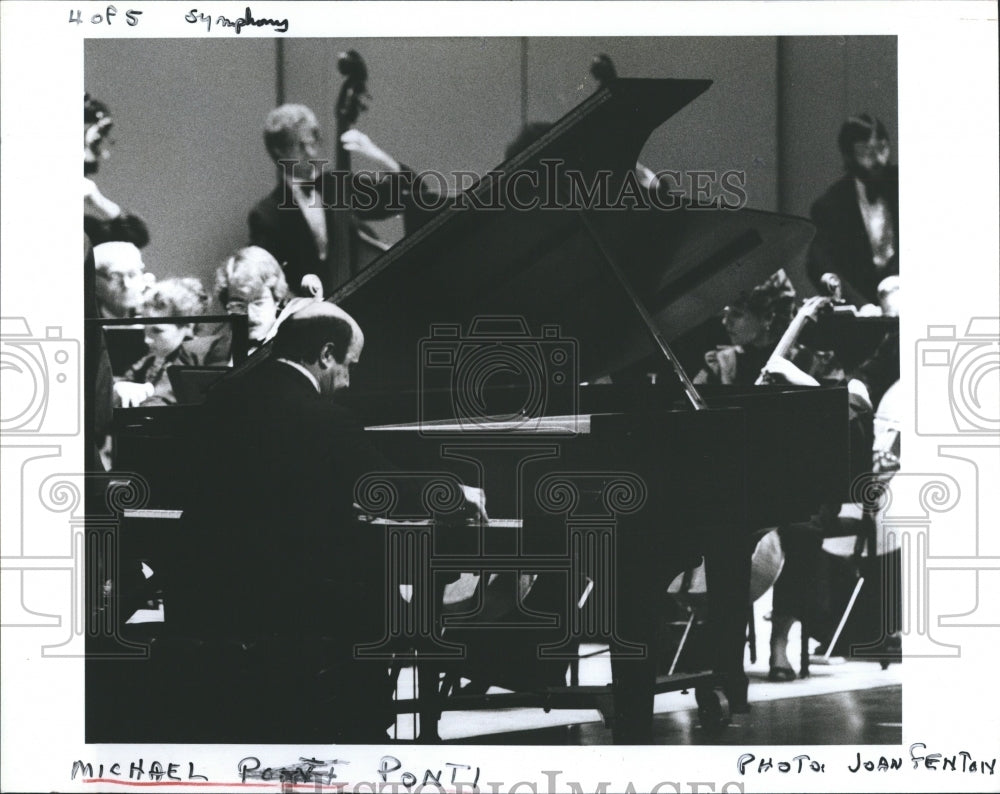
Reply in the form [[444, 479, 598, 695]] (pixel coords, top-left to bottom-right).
[[807, 113, 899, 306]]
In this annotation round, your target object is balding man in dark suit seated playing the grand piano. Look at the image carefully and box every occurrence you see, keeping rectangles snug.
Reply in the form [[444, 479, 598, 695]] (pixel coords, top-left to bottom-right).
[[173, 302, 485, 741]]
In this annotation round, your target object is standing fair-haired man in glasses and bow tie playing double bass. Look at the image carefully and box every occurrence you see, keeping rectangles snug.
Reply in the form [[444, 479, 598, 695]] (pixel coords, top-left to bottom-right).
[[248, 104, 404, 295]]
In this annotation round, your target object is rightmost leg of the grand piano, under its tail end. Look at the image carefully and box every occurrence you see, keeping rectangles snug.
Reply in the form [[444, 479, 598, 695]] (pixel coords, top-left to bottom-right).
[[705, 526, 753, 713]]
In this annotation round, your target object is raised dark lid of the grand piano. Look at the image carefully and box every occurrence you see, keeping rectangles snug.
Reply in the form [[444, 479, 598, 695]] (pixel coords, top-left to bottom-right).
[[331, 79, 813, 400]]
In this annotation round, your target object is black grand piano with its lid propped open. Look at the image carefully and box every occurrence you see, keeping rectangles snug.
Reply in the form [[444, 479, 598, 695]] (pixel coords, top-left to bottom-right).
[[92, 74, 848, 743]]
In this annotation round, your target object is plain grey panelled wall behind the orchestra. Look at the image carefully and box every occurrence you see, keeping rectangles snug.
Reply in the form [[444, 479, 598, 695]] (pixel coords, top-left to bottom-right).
[[85, 36, 897, 300]]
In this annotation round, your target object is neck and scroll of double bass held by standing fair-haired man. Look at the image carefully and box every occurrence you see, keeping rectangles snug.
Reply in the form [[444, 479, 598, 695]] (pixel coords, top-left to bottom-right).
[[327, 50, 389, 291]]
